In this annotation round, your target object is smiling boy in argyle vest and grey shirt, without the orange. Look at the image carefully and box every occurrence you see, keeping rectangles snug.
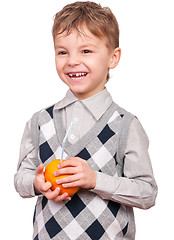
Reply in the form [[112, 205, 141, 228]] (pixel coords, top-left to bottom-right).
[[15, 2, 157, 240]]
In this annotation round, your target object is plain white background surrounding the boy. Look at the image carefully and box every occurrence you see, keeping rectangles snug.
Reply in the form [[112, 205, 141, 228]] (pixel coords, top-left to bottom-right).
[[0, 0, 174, 240]]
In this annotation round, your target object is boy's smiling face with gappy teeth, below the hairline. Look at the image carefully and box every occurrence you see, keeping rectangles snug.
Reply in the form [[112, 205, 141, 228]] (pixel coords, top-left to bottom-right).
[[55, 27, 120, 99]]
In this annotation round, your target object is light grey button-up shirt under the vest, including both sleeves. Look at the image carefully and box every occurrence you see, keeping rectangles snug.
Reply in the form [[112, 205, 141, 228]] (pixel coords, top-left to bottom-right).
[[15, 89, 157, 208]]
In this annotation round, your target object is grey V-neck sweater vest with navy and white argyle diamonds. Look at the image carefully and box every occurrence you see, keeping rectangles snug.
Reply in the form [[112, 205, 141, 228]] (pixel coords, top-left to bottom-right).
[[32, 103, 135, 240]]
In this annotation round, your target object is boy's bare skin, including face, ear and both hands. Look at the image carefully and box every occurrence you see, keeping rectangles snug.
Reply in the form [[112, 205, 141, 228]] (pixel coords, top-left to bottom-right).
[[34, 26, 121, 202]]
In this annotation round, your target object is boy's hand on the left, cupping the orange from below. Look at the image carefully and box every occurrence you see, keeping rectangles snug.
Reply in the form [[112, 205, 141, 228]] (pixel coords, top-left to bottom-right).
[[34, 164, 71, 202]]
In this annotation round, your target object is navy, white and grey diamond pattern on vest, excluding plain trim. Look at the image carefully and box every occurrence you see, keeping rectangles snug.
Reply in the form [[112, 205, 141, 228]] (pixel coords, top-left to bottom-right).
[[33, 106, 134, 240]]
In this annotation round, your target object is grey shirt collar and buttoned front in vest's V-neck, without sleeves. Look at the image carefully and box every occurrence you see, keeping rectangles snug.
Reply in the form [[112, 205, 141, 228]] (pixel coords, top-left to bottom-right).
[[55, 89, 113, 144]]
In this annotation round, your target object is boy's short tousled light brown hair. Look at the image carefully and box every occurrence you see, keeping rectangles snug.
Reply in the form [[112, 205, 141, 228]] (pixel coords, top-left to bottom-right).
[[52, 1, 119, 81]]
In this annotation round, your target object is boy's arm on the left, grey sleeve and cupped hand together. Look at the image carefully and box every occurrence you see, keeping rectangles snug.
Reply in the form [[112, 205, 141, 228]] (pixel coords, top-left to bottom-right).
[[14, 121, 71, 202]]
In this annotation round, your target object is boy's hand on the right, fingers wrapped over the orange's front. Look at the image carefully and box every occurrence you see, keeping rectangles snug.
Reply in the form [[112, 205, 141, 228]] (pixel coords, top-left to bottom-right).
[[54, 157, 96, 189]]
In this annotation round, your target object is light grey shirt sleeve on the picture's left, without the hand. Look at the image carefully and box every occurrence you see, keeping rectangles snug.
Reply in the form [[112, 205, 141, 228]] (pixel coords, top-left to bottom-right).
[[14, 121, 37, 198]]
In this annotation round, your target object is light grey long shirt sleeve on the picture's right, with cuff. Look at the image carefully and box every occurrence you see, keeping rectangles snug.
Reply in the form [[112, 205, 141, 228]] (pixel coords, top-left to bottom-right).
[[92, 118, 157, 209]]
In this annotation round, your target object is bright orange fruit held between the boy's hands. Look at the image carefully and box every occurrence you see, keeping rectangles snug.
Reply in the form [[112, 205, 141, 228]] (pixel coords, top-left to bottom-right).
[[45, 159, 79, 196]]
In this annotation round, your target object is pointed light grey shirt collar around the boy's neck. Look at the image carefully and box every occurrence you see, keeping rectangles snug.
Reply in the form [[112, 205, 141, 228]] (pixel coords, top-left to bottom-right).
[[55, 88, 113, 120]]
